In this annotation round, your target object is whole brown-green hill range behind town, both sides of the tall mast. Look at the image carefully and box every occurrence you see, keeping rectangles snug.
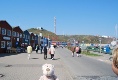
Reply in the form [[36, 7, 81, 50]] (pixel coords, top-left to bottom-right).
[[28, 28, 113, 44]]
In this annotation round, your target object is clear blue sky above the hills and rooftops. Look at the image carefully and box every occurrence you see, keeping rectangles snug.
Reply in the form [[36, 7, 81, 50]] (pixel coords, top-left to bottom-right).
[[0, 0, 118, 36]]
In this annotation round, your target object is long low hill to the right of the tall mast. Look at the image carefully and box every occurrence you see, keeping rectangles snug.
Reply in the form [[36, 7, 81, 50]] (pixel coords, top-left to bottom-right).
[[58, 35, 113, 44]]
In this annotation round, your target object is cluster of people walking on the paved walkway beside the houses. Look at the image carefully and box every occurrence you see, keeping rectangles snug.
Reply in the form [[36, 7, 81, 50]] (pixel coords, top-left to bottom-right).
[[27, 44, 55, 60]]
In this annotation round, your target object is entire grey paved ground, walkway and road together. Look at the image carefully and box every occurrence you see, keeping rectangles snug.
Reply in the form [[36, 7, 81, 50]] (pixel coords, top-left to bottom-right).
[[0, 48, 118, 80]]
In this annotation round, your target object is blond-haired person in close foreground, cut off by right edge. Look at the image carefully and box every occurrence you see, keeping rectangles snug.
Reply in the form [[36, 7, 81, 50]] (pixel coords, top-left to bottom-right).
[[112, 48, 118, 75]]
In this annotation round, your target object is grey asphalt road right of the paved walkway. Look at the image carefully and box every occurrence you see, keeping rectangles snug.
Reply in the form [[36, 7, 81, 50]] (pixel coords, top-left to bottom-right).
[[56, 48, 118, 80]]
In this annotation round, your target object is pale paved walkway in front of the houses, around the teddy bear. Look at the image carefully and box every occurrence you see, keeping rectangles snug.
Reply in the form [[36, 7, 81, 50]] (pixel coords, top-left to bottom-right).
[[0, 51, 73, 80]]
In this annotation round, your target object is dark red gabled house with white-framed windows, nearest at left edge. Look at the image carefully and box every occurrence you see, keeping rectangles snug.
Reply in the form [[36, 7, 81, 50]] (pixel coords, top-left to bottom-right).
[[0, 20, 12, 53]]
